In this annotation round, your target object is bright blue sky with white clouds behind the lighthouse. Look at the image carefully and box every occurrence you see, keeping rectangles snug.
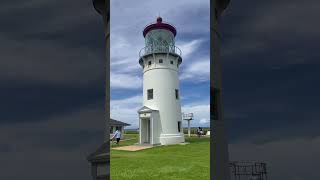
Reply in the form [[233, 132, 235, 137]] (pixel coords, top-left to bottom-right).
[[110, 0, 210, 128]]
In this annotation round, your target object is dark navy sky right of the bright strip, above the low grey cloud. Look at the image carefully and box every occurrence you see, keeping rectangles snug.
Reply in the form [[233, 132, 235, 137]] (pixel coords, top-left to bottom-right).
[[220, 1, 320, 141]]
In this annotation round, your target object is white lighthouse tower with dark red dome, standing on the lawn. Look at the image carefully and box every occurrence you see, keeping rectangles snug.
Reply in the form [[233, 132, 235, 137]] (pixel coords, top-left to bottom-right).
[[138, 17, 184, 145]]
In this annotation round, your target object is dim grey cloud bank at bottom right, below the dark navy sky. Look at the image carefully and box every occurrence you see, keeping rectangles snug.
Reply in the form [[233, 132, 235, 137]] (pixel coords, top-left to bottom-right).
[[229, 136, 320, 180]]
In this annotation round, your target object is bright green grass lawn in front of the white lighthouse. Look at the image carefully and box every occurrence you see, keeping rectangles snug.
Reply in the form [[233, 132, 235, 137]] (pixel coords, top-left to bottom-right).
[[110, 134, 210, 180]]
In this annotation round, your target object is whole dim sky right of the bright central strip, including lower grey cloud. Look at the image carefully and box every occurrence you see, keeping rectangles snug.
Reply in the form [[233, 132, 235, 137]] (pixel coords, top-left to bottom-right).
[[220, 0, 320, 180]]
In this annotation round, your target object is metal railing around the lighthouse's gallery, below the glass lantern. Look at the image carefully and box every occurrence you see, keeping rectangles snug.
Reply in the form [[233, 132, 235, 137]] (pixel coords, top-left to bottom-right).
[[139, 45, 182, 57]]
